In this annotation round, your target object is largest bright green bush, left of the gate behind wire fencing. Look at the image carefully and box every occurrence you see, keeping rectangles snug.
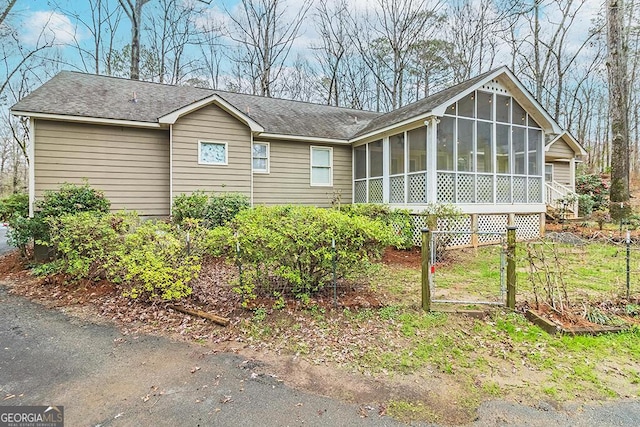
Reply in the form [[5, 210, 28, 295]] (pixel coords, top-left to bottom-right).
[[222, 206, 399, 302]]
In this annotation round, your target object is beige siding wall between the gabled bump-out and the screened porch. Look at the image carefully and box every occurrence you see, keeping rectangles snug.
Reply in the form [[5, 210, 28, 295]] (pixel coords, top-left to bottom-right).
[[253, 141, 352, 207]]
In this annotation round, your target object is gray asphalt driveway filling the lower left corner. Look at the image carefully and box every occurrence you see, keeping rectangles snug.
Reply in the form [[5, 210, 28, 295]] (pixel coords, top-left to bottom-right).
[[0, 284, 408, 426]]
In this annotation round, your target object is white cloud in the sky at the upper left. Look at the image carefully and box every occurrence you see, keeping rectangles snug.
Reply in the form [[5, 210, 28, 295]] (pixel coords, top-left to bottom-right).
[[21, 11, 76, 45]]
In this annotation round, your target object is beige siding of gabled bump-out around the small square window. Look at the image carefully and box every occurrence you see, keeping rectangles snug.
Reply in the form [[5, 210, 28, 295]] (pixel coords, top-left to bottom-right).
[[172, 105, 251, 197]]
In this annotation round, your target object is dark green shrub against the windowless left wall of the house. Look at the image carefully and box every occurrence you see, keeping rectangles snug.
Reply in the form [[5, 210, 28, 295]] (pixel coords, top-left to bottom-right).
[[37, 183, 111, 217]]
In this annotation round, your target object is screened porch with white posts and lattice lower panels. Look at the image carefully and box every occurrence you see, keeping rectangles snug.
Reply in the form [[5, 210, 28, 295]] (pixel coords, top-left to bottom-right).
[[353, 90, 545, 213]]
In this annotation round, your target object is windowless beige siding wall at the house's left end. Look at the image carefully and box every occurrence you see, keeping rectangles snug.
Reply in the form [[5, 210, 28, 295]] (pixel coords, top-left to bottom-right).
[[34, 120, 169, 216]]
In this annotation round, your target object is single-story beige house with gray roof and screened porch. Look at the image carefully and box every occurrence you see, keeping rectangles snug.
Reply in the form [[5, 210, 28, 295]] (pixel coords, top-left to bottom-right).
[[11, 67, 584, 247]]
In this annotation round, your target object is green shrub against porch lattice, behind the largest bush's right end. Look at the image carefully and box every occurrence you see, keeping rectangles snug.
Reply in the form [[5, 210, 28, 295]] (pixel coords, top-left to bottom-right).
[[340, 203, 414, 249]]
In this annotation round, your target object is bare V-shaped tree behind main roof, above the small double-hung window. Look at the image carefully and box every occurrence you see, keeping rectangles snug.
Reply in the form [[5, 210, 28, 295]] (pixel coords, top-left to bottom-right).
[[229, 0, 311, 97]]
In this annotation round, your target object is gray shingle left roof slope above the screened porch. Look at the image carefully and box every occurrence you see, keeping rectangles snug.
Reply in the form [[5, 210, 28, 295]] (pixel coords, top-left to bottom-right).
[[353, 70, 496, 137]]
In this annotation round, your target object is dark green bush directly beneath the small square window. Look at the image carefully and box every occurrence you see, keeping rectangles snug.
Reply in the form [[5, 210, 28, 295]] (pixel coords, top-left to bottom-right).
[[172, 191, 249, 228]]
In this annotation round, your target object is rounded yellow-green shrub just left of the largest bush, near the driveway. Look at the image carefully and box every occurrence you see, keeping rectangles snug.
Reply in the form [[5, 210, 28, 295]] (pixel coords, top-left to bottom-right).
[[110, 221, 201, 300]]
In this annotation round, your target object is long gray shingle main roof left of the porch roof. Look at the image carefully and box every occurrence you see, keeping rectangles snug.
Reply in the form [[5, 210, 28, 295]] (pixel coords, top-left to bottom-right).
[[11, 71, 380, 140]]
